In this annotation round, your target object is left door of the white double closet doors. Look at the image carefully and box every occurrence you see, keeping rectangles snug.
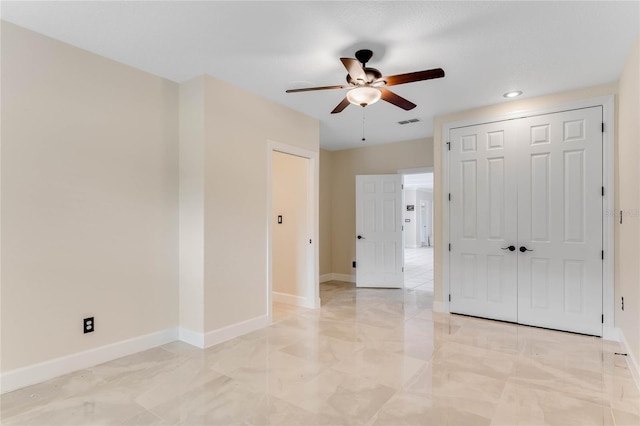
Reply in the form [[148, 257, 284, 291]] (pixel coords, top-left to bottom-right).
[[449, 121, 518, 322]]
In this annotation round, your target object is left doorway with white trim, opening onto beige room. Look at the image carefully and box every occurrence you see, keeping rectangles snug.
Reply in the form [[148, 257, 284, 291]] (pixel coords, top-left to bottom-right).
[[267, 142, 320, 322]]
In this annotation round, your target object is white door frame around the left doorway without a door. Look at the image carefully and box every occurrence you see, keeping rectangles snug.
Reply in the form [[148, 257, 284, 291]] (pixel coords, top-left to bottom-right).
[[266, 140, 320, 322]]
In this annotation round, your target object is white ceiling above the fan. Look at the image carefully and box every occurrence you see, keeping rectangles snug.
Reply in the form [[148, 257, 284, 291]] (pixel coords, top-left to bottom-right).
[[1, 1, 640, 150]]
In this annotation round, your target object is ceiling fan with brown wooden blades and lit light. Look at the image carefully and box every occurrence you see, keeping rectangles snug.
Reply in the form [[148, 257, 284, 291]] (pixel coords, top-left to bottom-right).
[[286, 49, 444, 114]]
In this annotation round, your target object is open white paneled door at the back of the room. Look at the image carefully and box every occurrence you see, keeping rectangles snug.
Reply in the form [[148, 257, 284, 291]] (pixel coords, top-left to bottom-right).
[[356, 175, 404, 288]]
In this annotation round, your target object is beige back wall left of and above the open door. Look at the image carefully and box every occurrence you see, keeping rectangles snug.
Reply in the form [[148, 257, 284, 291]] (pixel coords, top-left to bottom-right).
[[328, 138, 433, 275]]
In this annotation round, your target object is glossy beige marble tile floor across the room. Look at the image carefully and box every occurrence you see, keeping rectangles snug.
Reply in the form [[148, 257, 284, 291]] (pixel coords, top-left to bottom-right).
[[0, 281, 640, 426]]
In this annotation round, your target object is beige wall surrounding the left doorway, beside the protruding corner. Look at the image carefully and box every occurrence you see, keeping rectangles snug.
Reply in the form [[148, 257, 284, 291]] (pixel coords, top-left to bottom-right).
[[203, 76, 320, 331]]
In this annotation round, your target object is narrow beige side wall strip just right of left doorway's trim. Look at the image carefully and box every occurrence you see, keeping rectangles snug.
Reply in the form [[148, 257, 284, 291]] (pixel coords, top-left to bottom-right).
[[318, 149, 333, 276]]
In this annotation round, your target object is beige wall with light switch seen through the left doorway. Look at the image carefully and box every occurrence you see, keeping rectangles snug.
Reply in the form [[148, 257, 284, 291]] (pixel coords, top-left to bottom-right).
[[271, 152, 310, 298]]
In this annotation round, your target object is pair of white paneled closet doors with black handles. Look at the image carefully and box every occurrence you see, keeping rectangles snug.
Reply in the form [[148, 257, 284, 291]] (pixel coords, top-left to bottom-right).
[[450, 107, 603, 336]]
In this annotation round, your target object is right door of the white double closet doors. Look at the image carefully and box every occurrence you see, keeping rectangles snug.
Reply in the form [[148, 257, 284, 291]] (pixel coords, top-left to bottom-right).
[[518, 107, 603, 336]]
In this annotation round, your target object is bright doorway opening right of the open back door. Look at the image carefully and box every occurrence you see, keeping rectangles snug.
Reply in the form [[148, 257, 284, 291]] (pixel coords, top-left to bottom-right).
[[402, 169, 434, 293]]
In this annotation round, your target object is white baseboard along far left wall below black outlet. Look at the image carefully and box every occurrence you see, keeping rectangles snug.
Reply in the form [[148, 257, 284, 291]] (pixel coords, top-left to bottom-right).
[[0, 328, 178, 393]]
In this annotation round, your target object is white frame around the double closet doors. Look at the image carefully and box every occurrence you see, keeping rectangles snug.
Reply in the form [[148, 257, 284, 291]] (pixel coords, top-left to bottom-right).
[[440, 95, 619, 340]]
